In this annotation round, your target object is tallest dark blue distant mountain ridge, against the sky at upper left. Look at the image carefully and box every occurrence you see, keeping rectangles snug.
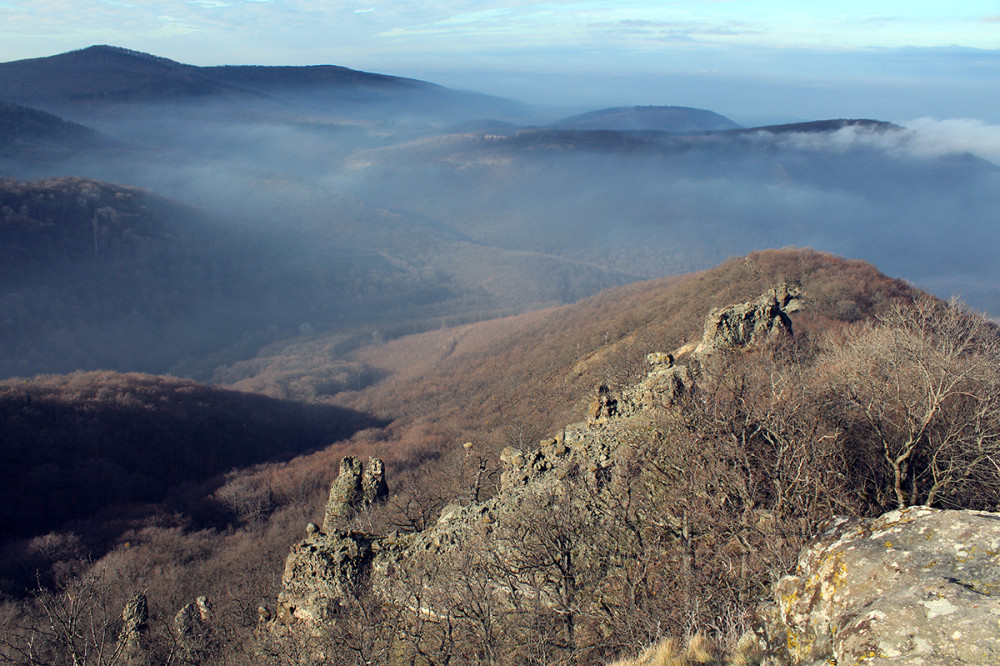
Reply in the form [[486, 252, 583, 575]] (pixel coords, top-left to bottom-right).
[[0, 45, 526, 118]]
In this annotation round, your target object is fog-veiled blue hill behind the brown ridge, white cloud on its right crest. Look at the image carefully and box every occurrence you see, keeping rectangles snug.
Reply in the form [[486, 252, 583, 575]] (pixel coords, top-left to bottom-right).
[[333, 120, 1000, 310]]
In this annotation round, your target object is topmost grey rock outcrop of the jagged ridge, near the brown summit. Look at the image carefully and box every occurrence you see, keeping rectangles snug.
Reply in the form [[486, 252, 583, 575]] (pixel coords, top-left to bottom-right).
[[695, 284, 799, 354]]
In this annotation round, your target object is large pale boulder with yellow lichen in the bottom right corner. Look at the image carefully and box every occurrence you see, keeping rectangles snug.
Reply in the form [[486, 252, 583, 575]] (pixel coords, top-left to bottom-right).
[[761, 507, 1000, 664]]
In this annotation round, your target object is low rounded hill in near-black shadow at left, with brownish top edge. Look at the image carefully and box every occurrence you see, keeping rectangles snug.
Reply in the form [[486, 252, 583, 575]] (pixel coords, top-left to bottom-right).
[[0, 372, 385, 541]]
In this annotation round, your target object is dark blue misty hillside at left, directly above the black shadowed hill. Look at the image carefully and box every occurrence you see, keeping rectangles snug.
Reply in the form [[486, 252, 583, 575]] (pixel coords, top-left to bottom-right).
[[0, 178, 466, 376]]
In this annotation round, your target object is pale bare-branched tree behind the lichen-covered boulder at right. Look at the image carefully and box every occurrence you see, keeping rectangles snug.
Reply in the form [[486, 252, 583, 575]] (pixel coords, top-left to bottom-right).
[[823, 298, 1000, 508]]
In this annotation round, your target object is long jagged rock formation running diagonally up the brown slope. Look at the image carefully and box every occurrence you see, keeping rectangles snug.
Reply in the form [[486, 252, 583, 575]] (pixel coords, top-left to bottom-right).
[[277, 285, 796, 626]]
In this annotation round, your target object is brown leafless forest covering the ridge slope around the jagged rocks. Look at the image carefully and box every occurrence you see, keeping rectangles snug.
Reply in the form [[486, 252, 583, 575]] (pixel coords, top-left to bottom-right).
[[9, 250, 993, 664]]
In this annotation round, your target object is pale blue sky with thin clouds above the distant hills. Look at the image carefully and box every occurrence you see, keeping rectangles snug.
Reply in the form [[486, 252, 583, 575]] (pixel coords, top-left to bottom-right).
[[0, 0, 1000, 123]]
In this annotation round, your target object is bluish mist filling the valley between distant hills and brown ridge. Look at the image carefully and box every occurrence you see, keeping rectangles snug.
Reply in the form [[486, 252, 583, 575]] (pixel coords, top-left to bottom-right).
[[0, 89, 1000, 377]]
